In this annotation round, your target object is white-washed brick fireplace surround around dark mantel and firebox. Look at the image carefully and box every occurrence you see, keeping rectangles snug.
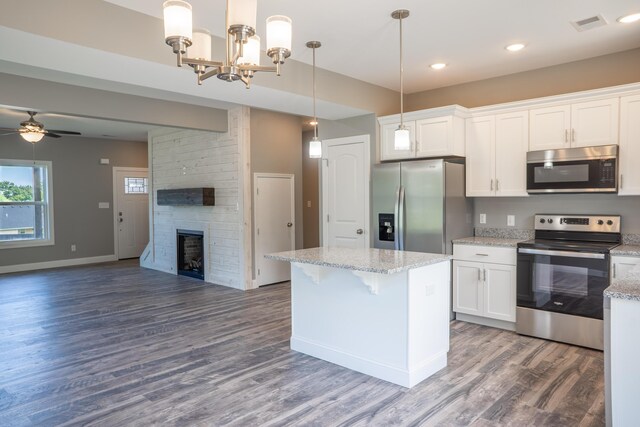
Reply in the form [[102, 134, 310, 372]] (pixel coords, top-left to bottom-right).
[[140, 107, 251, 289]]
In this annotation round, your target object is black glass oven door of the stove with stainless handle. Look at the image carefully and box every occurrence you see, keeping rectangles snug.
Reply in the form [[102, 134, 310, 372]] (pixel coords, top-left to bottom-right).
[[517, 247, 609, 319]]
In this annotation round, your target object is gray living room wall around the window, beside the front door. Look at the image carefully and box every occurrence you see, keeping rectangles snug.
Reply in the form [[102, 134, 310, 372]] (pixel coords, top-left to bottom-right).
[[0, 135, 147, 266]]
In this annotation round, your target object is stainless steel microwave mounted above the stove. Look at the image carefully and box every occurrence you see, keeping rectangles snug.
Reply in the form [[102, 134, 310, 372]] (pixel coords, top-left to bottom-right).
[[527, 145, 618, 193]]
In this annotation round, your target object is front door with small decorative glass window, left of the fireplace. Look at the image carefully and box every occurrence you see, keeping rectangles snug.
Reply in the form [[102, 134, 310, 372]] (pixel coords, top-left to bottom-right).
[[113, 167, 149, 259]]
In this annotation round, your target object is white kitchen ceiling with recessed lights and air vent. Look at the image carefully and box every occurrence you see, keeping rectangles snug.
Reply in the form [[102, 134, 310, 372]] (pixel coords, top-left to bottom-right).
[[107, 0, 640, 93]]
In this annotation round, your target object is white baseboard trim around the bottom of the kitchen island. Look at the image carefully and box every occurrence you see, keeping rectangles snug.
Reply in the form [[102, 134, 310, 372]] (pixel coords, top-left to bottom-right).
[[290, 336, 447, 388]]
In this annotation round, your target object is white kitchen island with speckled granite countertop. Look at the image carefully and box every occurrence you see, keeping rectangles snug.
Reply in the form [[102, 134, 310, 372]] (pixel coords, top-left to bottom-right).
[[266, 248, 451, 387]]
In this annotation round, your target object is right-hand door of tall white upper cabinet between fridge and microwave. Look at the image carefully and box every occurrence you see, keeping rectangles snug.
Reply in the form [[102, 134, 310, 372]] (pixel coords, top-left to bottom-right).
[[495, 111, 529, 197]]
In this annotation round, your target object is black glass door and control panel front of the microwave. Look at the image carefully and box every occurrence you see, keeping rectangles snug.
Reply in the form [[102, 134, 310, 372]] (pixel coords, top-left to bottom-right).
[[527, 158, 617, 193]]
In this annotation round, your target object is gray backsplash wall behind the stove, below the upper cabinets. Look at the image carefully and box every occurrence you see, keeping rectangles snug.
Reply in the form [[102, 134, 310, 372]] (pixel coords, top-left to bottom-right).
[[474, 194, 640, 233]]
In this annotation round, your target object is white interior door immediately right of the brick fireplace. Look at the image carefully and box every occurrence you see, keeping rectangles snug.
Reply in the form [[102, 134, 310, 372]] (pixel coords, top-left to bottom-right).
[[253, 173, 296, 286]]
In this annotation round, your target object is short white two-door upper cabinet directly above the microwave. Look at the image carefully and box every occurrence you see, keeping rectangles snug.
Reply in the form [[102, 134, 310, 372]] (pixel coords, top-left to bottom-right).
[[529, 98, 619, 151]]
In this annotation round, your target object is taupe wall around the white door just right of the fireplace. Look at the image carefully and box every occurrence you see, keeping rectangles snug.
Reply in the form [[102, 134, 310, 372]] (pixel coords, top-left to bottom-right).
[[251, 108, 304, 274]]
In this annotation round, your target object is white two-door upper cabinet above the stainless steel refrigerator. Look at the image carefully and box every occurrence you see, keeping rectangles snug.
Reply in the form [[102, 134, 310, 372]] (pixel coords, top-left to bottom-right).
[[378, 106, 467, 161]]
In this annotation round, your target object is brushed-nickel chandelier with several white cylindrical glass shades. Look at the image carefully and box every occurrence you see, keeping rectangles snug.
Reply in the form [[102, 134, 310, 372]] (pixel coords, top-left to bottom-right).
[[163, 0, 291, 88]]
